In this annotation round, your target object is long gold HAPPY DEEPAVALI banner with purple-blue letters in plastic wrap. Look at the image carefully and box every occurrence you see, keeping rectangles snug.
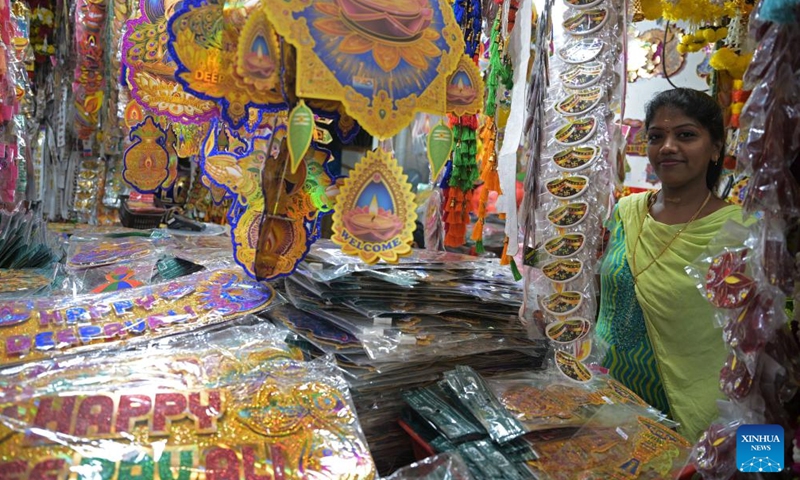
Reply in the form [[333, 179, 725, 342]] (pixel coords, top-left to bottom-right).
[[0, 270, 274, 365]]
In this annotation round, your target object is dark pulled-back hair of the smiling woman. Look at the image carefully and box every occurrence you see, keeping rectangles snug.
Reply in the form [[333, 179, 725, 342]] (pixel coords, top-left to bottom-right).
[[644, 88, 725, 192]]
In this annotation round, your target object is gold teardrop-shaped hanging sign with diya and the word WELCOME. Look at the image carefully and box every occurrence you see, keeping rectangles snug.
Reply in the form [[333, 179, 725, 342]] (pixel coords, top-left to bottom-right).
[[332, 149, 417, 264]]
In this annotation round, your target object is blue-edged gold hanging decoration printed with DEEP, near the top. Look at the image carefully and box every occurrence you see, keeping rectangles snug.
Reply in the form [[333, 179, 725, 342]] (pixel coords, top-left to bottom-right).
[[167, 0, 294, 128]]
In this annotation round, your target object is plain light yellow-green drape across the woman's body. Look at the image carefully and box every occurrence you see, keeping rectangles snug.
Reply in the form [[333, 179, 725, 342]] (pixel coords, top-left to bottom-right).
[[611, 194, 742, 440]]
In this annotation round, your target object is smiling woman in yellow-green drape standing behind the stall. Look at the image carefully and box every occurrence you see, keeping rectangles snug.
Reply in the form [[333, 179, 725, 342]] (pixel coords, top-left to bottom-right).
[[597, 88, 742, 440]]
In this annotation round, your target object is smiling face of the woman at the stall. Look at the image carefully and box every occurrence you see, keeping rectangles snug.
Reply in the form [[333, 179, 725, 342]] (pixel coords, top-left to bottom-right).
[[647, 107, 721, 188]]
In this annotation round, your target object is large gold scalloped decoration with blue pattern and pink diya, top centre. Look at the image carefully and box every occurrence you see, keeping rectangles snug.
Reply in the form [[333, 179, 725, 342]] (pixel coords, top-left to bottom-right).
[[263, 0, 462, 138]]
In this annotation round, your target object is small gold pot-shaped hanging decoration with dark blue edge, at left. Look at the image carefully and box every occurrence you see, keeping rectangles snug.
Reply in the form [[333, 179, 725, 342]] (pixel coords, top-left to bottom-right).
[[122, 116, 170, 193]]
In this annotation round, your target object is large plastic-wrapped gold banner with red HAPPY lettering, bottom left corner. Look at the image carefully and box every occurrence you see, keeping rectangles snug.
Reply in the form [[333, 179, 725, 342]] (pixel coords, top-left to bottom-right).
[[0, 341, 376, 480]]
